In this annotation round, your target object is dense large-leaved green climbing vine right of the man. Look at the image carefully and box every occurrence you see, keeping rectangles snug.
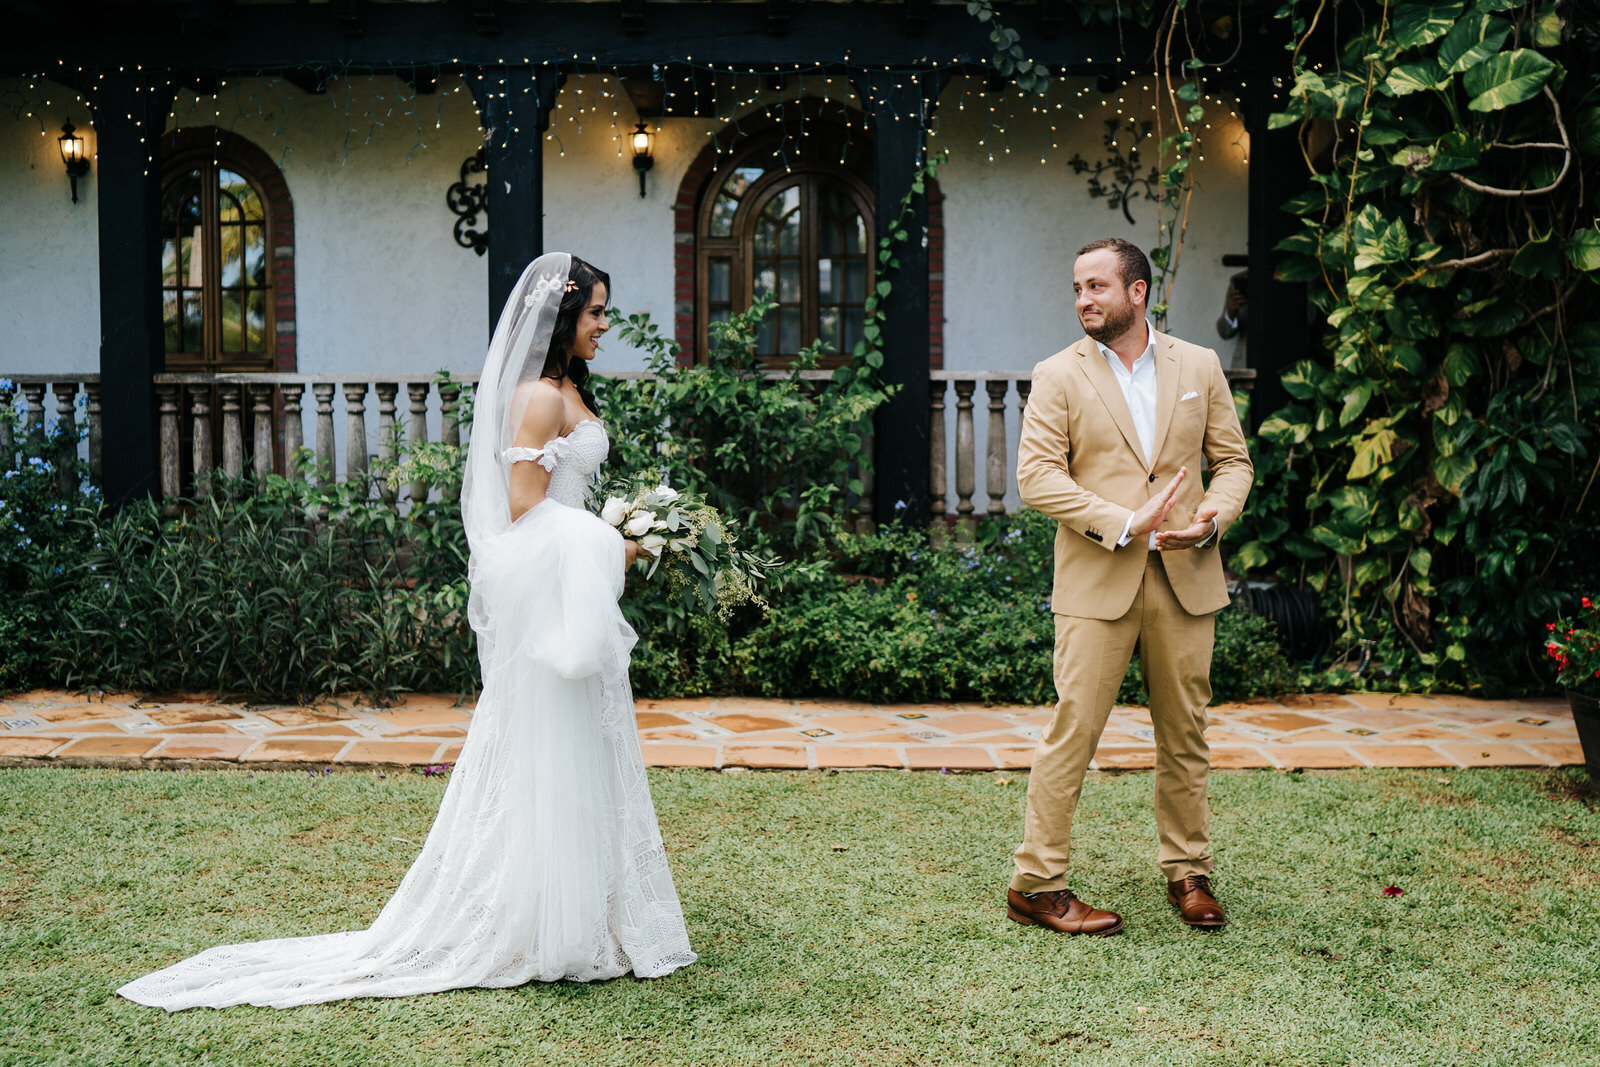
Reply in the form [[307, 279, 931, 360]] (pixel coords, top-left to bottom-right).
[[1232, 0, 1600, 688]]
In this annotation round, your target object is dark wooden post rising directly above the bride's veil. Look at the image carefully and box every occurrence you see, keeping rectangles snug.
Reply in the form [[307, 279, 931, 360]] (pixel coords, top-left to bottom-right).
[[467, 66, 566, 334]]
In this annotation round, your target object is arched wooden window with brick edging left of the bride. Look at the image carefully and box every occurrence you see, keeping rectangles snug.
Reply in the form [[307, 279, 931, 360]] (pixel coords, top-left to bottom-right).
[[162, 128, 294, 373]]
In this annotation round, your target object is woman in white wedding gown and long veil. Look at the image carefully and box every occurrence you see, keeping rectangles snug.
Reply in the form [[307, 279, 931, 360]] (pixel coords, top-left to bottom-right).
[[117, 253, 694, 1011]]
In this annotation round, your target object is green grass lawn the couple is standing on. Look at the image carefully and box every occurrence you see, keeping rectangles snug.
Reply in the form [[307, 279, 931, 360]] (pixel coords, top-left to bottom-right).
[[0, 768, 1600, 1067]]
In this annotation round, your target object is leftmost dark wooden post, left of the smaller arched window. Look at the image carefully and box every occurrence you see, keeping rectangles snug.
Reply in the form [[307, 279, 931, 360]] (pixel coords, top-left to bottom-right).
[[91, 74, 173, 502]]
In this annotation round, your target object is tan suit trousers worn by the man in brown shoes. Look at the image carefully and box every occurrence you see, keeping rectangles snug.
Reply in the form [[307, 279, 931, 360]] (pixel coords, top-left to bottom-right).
[[1011, 549, 1216, 893]]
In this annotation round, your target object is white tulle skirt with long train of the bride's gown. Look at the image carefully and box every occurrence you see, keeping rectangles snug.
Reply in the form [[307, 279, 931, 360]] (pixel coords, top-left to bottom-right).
[[117, 501, 694, 1011]]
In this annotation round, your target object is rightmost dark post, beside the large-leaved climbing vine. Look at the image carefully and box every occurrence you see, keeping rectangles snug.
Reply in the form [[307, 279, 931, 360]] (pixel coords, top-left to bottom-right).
[[1245, 74, 1310, 429]]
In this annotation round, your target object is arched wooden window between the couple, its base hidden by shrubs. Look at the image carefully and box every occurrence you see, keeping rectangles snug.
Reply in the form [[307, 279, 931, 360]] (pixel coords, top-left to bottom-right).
[[694, 118, 875, 366]]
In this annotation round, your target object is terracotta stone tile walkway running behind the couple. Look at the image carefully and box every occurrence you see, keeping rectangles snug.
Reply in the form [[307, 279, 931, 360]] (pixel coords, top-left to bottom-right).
[[0, 689, 1582, 771]]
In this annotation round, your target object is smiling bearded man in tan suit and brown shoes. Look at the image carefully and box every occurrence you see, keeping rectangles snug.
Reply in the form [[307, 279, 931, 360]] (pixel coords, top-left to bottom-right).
[[1006, 238, 1253, 934]]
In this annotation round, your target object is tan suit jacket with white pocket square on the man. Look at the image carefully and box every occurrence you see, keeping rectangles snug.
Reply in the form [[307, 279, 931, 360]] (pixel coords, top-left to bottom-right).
[[1016, 331, 1254, 619]]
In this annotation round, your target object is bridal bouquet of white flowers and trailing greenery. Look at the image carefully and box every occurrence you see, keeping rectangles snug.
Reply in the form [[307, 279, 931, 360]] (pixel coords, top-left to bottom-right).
[[600, 485, 778, 619]]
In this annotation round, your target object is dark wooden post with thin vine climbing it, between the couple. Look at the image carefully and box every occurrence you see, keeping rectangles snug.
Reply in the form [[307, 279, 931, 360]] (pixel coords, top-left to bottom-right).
[[856, 72, 944, 523]]
